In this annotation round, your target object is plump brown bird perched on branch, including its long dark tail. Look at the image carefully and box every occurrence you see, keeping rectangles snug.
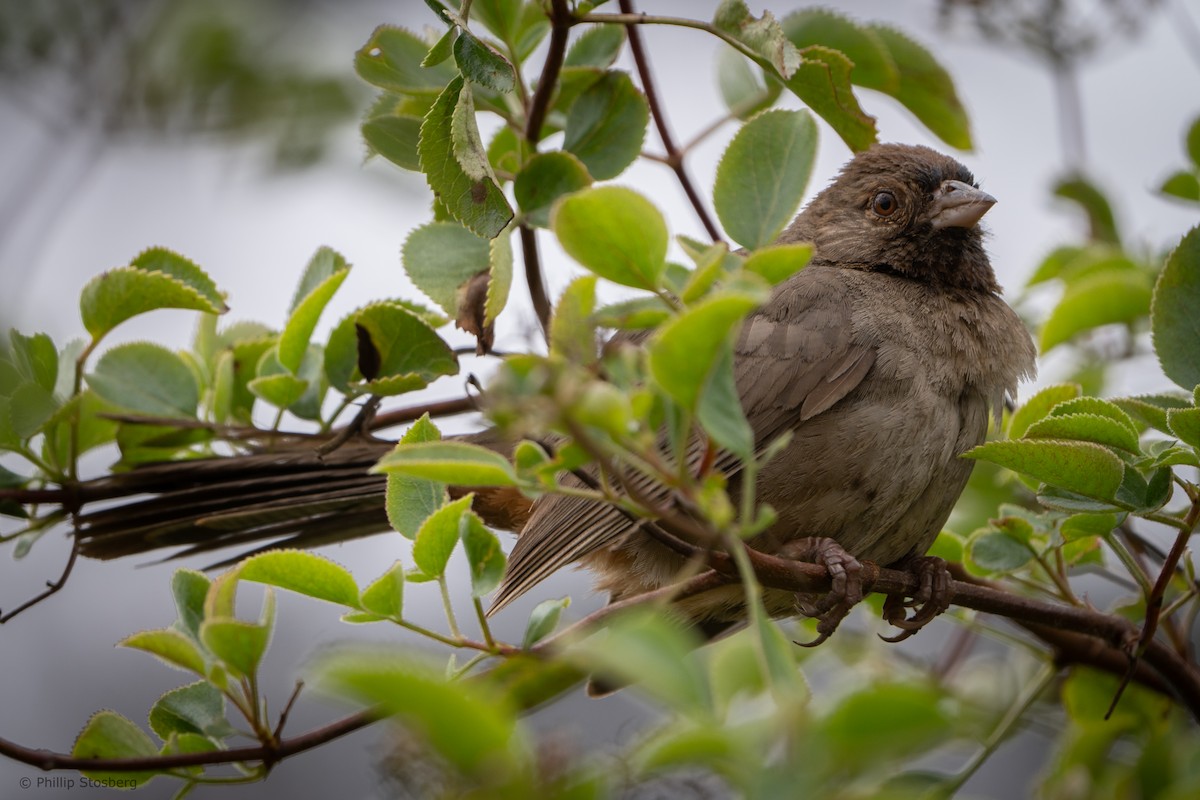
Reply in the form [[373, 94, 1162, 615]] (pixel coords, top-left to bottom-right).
[[63, 144, 1036, 638]]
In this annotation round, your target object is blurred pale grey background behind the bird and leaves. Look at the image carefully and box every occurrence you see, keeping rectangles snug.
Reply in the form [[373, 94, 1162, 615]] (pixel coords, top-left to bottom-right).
[[0, 0, 1200, 799]]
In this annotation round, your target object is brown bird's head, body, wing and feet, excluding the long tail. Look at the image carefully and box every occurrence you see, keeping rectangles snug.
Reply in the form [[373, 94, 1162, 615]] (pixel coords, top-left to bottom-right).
[[493, 144, 1036, 636]]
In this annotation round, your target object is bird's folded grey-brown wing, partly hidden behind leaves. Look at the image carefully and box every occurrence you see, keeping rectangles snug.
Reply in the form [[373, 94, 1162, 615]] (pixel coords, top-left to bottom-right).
[[490, 267, 875, 613]]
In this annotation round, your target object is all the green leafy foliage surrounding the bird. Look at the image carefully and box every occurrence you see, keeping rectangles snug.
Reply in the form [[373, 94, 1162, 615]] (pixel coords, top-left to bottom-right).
[[0, 0, 1200, 798]]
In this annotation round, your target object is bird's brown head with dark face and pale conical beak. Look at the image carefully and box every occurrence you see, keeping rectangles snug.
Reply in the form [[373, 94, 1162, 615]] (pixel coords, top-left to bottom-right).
[[785, 144, 998, 291]]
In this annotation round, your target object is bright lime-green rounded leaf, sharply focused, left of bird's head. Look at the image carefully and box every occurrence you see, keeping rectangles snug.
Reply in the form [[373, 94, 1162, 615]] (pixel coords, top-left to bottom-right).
[[551, 186, 667, 290]]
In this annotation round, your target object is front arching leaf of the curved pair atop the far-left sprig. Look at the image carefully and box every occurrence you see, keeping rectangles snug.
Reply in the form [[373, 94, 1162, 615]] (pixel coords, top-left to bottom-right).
[[79, 266, 228, 339]]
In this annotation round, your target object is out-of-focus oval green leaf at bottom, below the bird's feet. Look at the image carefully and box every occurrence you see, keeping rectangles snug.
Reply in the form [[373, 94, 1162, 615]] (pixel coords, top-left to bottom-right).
[[812, 681, 950, 770]]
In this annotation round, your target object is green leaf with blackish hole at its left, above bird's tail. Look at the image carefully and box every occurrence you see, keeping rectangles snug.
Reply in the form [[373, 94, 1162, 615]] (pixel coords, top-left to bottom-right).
[[355, 302, 458, 395]]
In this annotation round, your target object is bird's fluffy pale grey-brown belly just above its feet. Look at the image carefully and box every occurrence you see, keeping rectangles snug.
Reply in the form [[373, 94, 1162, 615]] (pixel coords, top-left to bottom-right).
[[755, 384, 988, 565]]
